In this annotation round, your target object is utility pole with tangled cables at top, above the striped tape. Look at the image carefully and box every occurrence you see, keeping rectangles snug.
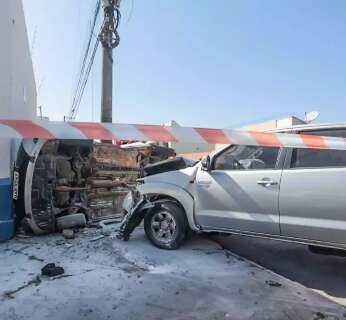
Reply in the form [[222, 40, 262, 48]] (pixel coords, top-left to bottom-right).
[[99, 0, 121, 123]]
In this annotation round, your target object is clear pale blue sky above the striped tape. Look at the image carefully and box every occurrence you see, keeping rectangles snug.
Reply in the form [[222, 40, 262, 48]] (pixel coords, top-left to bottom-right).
[[23, 0, 346, 128]]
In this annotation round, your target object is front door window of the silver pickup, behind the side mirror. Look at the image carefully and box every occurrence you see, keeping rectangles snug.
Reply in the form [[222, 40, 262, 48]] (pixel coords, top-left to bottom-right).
[[214, 145, 280, 170]]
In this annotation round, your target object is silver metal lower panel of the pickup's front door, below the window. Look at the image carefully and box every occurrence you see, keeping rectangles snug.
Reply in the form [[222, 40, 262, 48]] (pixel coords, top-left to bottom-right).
[[196, 170, 281, 235]]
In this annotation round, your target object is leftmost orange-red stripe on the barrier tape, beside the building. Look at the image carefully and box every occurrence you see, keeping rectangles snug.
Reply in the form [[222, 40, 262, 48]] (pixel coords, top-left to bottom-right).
[[0, 120, 55, 139]]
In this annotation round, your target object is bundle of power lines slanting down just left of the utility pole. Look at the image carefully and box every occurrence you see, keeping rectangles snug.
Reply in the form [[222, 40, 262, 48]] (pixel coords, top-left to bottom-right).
[[69, 0, 101, 120]]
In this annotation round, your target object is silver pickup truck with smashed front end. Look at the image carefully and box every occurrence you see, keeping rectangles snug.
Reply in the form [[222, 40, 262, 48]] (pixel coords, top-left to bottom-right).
[[122, 124, 346, 249]]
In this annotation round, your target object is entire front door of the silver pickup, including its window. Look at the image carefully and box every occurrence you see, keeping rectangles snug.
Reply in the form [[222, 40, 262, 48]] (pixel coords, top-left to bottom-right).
[[194, 145, 283, 235]]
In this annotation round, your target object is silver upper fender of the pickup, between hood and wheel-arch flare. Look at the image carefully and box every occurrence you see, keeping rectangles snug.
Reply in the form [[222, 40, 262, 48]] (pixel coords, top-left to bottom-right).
[[140, 166, 198, 189]]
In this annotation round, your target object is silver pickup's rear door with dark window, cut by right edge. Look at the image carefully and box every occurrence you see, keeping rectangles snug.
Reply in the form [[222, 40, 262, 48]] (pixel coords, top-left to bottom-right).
[[280, 149, 346, 244]]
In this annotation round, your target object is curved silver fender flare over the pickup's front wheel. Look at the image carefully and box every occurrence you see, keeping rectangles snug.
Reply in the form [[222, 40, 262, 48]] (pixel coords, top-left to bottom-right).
[[137, 182, 201, 231]]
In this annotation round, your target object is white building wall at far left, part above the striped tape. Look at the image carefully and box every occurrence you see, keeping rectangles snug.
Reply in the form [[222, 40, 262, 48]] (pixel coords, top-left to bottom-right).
[[0, 0, 36, 119]]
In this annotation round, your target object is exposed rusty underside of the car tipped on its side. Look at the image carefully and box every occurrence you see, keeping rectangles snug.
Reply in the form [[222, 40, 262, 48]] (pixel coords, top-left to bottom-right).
[[15, 140, 174, 234]]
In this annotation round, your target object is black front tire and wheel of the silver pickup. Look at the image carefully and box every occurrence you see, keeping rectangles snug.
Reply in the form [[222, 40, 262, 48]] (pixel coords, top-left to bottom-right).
[[144, 202, 188, 250]]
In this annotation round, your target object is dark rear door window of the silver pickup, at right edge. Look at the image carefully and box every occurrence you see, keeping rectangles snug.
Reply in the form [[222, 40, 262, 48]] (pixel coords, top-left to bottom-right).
[[291, 149, 346, 168]]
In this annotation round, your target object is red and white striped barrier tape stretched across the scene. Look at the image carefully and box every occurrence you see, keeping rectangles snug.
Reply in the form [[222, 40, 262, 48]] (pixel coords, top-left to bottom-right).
[[0, 120, 346, 150]]
